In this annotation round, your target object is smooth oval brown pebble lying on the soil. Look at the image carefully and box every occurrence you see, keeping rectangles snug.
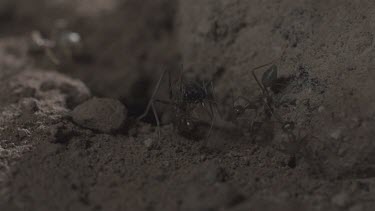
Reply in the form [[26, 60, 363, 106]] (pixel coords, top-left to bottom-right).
[[71, 98, 127, 133]]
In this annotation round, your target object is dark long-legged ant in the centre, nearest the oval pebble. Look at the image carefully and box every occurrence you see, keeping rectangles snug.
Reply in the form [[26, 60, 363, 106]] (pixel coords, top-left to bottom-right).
[[137, 70, 216, 139]]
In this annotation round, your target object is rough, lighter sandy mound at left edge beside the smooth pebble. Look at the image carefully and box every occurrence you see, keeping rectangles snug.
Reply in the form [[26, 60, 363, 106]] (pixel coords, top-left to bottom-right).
[[0, 64, 90, 206]]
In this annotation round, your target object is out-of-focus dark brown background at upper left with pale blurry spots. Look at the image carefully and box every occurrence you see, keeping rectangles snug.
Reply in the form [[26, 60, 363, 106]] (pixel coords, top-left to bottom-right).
[[0, 0, 179, 115]]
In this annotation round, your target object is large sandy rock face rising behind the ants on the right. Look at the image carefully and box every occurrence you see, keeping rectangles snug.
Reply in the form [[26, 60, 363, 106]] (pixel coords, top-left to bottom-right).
[[179, 0, 375, 177]]
